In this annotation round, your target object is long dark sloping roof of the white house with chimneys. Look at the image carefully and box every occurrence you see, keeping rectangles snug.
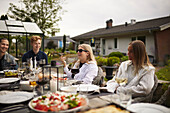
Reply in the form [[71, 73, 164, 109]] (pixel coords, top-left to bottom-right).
[[72, 16, 170, 40]]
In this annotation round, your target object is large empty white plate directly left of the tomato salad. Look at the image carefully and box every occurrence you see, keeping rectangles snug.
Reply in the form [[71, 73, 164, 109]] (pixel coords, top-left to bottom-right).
[[0, 92, 33, 104]]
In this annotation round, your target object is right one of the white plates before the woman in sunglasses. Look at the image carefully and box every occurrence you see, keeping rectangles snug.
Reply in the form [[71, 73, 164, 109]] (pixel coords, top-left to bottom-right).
[[73, 84, 99, 92]]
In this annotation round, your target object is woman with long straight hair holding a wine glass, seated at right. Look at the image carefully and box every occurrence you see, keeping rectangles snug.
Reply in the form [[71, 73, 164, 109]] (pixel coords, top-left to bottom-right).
[[107, 40, 155, 98]]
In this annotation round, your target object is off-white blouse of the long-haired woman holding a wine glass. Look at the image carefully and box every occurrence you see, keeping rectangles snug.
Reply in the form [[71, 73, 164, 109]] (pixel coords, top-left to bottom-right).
[[107, 60, 155, 97]]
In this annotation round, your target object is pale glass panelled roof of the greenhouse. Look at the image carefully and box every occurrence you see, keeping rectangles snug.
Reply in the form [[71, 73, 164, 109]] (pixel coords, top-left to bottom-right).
[[0, 20, 43, 34]]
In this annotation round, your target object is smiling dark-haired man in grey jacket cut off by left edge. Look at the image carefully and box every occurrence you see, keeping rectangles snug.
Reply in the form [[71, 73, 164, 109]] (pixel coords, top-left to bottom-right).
[[0, 38, 18, 71]]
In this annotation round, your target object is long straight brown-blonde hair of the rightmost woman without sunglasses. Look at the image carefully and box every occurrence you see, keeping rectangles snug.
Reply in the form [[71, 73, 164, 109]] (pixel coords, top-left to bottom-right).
[[129, 40, 152, 74]]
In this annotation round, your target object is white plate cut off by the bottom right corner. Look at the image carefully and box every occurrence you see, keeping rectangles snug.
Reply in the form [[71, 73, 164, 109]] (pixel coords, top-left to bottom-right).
[[127, 103, 170, 113]]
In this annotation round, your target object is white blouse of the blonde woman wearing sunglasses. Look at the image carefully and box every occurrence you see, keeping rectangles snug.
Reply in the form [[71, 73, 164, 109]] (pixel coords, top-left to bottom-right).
[[64, 61, 98, 84]]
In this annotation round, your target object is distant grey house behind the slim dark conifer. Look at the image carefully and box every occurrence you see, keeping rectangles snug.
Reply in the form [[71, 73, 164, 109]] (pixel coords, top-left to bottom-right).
[[44, 36, 75, 48]]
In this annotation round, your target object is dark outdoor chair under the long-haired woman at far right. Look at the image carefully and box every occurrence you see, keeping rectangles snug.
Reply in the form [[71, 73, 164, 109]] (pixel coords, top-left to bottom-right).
[[132, 75, 158, 103]]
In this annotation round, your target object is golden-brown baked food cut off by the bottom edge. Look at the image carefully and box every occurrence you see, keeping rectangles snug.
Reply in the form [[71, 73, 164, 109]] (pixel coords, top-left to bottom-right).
[[83, 105, 130, 113]]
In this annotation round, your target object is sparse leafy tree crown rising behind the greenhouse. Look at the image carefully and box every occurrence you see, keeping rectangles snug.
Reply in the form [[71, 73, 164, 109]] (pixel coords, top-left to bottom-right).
[[8, 0, 65, 34]]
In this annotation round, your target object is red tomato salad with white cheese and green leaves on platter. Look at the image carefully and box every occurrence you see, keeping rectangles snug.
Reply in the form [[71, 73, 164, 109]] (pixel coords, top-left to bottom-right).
[[29, 92, 87, 112]]
